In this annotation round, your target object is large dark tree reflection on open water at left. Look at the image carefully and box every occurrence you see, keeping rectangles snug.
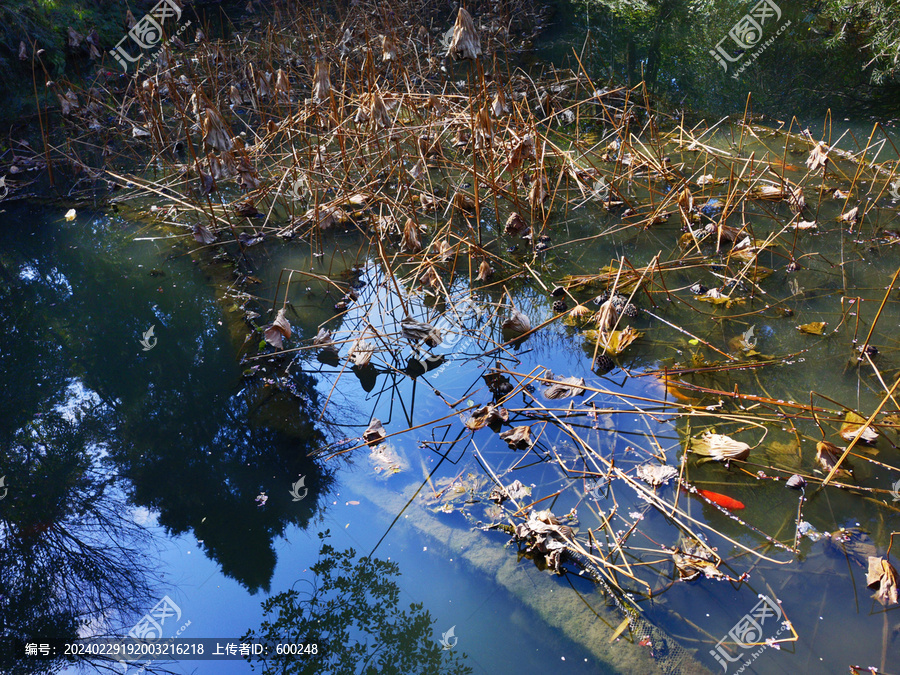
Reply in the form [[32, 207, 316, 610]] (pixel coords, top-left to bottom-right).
[[0, 206, 330, 673]]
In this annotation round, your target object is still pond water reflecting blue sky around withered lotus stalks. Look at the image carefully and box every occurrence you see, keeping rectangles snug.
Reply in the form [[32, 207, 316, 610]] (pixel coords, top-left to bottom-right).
[[0, 5, 900, 674]]
